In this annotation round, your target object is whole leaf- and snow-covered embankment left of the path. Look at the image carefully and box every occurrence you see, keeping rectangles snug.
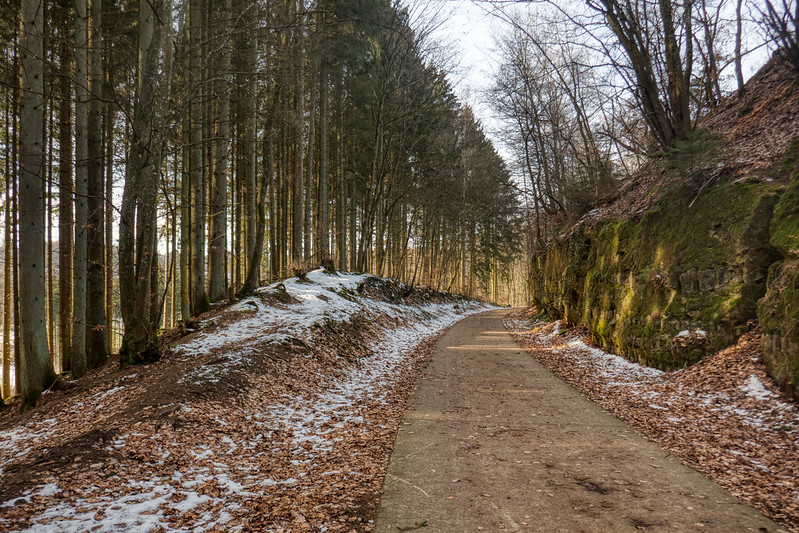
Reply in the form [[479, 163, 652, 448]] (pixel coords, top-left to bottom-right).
[[0, 270, 487, 533]]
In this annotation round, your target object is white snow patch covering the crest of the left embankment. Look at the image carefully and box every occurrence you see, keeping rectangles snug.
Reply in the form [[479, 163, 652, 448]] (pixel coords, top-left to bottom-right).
[[175, 269, 486, 383]]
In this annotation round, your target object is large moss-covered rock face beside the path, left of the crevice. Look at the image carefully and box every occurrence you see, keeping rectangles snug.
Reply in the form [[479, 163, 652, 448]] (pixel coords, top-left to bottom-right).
[[530, 175, 781, 368]]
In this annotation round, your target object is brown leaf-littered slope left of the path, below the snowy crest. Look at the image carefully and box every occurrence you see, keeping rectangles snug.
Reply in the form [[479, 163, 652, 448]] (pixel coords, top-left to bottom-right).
[[0, 317, 440, 532]]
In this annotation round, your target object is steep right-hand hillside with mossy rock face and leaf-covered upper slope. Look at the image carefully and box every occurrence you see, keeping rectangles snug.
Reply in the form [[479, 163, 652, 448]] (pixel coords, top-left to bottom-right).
[[530, 57, 799, 400]]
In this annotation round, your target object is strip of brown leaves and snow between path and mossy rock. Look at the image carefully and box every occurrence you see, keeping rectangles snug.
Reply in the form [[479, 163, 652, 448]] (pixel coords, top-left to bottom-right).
[[505, 313, 799, 531]]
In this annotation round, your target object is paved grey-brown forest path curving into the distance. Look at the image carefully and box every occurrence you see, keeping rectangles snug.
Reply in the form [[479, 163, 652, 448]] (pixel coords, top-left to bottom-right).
[[375, 309, 782, 533]]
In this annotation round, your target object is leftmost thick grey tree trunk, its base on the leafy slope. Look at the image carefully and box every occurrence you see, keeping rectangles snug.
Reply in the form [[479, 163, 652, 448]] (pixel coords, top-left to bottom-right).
[[19, 0, 56, 406]]
